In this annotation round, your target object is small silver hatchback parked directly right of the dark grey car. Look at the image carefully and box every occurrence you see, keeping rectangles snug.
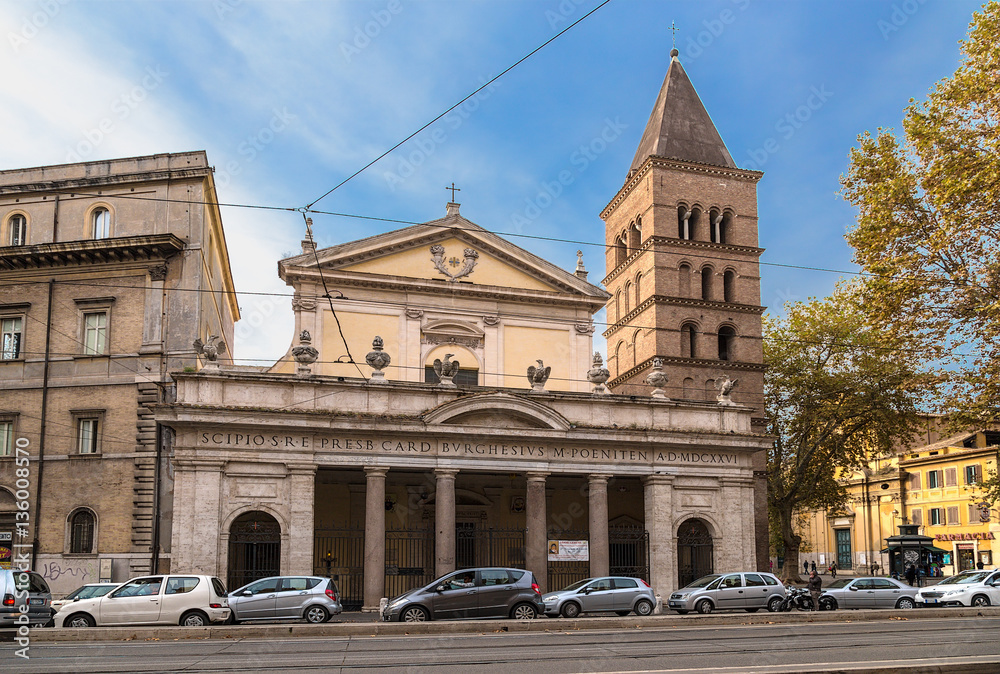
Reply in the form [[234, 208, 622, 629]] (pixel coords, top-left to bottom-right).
[[542, 576, 656, 618]]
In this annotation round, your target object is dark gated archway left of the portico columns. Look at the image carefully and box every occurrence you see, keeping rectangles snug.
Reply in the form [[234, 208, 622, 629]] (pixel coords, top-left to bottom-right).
[[226, 510, 281, 590]]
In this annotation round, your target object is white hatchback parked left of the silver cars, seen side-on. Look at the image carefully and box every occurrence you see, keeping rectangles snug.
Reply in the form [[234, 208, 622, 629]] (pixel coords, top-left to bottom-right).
[[55, 574, 230, 627]]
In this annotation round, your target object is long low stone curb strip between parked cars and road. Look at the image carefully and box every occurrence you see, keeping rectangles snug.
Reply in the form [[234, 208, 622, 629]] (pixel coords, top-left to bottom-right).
[[21, 606, 1000, 643]]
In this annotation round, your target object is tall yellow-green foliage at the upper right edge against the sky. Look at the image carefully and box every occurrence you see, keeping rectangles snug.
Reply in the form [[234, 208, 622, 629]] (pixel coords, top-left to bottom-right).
[[841, 1, 1000, 428]]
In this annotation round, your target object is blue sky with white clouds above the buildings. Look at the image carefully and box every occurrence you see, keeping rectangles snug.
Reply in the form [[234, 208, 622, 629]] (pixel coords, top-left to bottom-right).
[[0, 0, 981, 362]]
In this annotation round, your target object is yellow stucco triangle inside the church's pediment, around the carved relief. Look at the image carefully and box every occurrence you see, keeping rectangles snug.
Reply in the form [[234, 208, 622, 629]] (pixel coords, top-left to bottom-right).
[[341, 238, 556, 291]]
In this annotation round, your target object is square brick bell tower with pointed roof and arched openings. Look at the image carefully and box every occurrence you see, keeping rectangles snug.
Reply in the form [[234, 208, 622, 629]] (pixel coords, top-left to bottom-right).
[[601, 49, 768, 570]]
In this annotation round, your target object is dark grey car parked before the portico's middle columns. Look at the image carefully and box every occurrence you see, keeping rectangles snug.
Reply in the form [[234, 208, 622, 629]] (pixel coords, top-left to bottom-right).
[[382, 568, 545, 622]]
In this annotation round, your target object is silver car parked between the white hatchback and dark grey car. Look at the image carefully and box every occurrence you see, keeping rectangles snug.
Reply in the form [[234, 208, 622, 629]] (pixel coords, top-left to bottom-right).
[[229, 576, 343, 623]]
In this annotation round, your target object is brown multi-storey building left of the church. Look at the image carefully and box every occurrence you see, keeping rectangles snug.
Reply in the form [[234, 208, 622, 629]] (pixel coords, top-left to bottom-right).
[[0, 152, 239, 593]]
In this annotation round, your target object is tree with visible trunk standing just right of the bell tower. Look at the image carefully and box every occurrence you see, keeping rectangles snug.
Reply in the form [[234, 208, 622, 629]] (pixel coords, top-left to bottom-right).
[[764, 283, 935, 582]]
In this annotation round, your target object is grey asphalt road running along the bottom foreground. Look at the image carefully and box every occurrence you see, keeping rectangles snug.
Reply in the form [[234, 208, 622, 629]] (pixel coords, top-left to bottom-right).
[[0, 616, 1000, 674]]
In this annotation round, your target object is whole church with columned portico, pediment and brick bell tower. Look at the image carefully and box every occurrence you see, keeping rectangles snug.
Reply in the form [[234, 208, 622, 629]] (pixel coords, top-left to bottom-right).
[[156, 48, 770, 609]]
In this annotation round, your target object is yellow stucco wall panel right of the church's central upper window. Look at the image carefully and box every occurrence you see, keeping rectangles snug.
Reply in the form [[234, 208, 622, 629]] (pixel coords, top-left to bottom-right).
[[503, 326, 572, 391]]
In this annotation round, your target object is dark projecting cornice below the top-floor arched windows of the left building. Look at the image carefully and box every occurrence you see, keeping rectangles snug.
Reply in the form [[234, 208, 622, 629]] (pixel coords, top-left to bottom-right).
[[0, 234, 184, 269]]
